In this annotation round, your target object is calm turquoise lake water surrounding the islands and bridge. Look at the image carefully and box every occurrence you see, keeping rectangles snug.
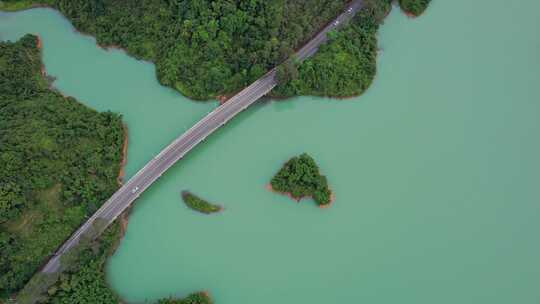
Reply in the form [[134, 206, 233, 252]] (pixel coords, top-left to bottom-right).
[[0, 0, 540, 304]]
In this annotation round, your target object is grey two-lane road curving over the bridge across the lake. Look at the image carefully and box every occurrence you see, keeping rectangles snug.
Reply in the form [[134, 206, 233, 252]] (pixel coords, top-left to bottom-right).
[[41, 0, 363, 273]]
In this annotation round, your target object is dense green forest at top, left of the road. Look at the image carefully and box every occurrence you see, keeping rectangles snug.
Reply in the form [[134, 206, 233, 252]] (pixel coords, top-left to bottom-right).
[[4, 0, 346, 99]]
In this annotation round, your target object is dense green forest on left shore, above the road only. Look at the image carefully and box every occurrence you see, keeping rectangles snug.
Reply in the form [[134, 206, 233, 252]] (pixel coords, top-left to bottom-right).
[[0, 35, 124, 296]]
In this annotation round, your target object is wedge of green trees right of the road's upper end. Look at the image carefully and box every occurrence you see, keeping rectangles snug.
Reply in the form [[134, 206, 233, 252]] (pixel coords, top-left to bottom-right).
[[272, 0, 391, 97]]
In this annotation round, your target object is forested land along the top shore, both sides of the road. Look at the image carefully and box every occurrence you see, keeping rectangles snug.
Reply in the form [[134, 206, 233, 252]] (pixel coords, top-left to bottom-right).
[[0, 0, 429, 100]]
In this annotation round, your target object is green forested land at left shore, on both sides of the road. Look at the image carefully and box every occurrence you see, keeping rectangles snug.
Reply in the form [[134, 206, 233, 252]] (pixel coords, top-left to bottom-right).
[[0, 35, 211, 304]]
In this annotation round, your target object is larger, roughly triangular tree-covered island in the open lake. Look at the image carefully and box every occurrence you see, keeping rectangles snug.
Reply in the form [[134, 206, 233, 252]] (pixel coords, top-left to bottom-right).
[[270, 153, 332, 206]]
